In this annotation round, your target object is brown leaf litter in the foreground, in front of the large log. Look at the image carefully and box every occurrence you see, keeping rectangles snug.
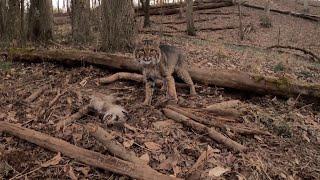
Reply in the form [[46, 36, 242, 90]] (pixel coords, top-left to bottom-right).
[[0, 63, 320, 178]]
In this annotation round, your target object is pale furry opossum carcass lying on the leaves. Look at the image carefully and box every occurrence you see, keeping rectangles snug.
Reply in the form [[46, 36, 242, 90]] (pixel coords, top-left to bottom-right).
[[90, 93, 128, 125]]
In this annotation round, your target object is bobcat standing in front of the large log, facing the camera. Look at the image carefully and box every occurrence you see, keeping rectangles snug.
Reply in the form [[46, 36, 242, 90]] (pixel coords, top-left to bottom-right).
[[134, 40, 196, 105]]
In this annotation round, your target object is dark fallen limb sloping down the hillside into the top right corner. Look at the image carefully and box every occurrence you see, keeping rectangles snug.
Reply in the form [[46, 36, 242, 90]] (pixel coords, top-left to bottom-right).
[[243, 3, 320, 22]]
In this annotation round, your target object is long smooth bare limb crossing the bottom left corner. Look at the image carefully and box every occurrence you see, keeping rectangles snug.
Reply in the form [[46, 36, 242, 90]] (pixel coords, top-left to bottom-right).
[[0, 121, 176, 180]]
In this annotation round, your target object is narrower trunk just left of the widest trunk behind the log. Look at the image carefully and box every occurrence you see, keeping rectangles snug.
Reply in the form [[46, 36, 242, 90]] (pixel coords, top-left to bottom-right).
[[71, 0, 91, 43]]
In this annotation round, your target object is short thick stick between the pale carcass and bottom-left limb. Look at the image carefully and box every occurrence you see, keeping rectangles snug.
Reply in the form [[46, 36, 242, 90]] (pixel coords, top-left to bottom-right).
[[85, 123, 144, 165]]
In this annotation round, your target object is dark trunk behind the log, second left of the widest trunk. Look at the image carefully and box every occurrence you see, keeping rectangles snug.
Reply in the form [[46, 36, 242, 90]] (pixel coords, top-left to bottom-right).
[[28, 0, 53, 41]]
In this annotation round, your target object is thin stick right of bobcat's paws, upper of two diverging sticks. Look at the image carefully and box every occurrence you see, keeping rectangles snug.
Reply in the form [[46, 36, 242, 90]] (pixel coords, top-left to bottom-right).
[[167, 105, 270, 135]]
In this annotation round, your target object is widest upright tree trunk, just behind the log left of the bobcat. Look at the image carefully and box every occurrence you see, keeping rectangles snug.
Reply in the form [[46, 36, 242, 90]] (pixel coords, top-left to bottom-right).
[[101, 0, 136, 52]]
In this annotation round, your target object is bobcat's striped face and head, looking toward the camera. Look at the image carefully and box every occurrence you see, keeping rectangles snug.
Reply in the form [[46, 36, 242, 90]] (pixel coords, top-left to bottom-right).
[[134, 40, 161, 66]]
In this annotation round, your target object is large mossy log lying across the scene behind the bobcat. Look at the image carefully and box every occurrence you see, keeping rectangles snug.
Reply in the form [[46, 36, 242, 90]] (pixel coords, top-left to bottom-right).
[[0, 49, 320, 97]]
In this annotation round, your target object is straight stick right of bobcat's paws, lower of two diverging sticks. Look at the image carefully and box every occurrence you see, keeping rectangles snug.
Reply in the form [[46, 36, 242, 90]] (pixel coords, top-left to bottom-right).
[[163, 108, 247, 152]]
